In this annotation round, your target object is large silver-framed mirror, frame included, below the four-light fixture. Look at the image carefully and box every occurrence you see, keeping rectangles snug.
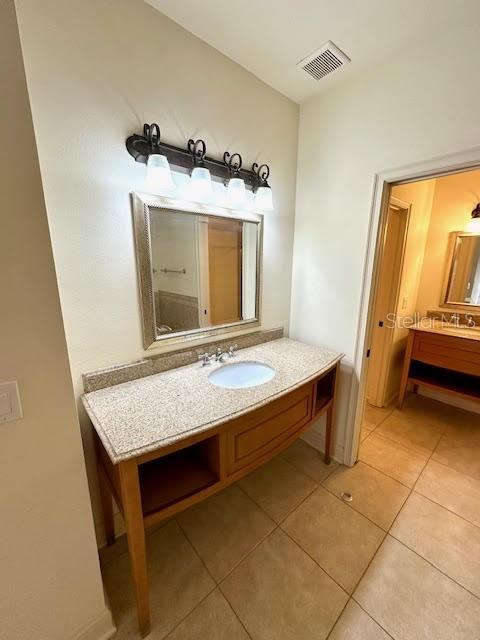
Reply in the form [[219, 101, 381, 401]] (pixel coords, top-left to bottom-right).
[[133, 193, 263, 348]]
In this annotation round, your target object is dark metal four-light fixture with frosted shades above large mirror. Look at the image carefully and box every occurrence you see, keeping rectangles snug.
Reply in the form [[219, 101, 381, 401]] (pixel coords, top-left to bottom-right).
[[126, 123, 273, 211]]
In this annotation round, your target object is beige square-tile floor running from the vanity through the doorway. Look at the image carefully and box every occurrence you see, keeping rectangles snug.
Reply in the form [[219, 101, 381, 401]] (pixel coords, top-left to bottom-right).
[[101, 395, 480, 640]]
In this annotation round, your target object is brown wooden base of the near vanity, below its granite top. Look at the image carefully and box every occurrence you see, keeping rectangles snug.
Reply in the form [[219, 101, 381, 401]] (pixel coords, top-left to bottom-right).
[[96, 362, 339, 636]]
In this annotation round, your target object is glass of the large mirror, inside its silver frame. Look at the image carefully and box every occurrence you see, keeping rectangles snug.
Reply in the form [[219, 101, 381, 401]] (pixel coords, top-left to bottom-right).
[[149, 208, 259, 337]]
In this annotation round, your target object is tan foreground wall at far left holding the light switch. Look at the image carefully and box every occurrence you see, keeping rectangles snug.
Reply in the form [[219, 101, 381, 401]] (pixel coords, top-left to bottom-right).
[[0, 0, 111, 640]]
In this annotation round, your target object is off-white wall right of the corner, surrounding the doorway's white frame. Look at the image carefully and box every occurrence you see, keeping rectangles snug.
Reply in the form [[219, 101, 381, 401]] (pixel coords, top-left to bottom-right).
[[290, 24, 480, 460]]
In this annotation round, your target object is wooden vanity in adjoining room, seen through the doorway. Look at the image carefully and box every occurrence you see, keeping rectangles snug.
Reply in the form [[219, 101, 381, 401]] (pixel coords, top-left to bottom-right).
[[399, 318, 480, 407]]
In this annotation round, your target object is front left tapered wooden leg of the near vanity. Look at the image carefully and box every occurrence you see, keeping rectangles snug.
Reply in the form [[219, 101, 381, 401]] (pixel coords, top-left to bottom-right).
[[118, 460, 150, 638]]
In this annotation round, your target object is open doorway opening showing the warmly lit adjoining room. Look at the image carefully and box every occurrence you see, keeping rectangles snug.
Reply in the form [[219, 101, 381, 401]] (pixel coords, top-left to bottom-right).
[[357, 162, 480, 470]]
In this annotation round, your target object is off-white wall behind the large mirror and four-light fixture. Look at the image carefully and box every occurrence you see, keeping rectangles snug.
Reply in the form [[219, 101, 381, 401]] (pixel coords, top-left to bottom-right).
[[17, 0, 298, 540]]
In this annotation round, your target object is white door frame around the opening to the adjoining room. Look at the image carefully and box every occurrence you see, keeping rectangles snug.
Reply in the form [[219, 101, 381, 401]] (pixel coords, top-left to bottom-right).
[[344, 146, 480, 466]]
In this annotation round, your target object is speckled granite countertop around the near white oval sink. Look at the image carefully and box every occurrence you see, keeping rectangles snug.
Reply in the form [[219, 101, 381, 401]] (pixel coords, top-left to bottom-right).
[[82, 338, 343, 464]]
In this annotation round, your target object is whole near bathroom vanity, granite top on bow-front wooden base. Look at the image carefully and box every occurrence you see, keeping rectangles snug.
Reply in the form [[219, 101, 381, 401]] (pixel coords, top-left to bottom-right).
[[83, 338, 344, 636]]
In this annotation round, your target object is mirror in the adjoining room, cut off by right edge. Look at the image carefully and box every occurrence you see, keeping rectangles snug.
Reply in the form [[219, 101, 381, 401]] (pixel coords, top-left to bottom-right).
[[445, 233, 480, 306]]
